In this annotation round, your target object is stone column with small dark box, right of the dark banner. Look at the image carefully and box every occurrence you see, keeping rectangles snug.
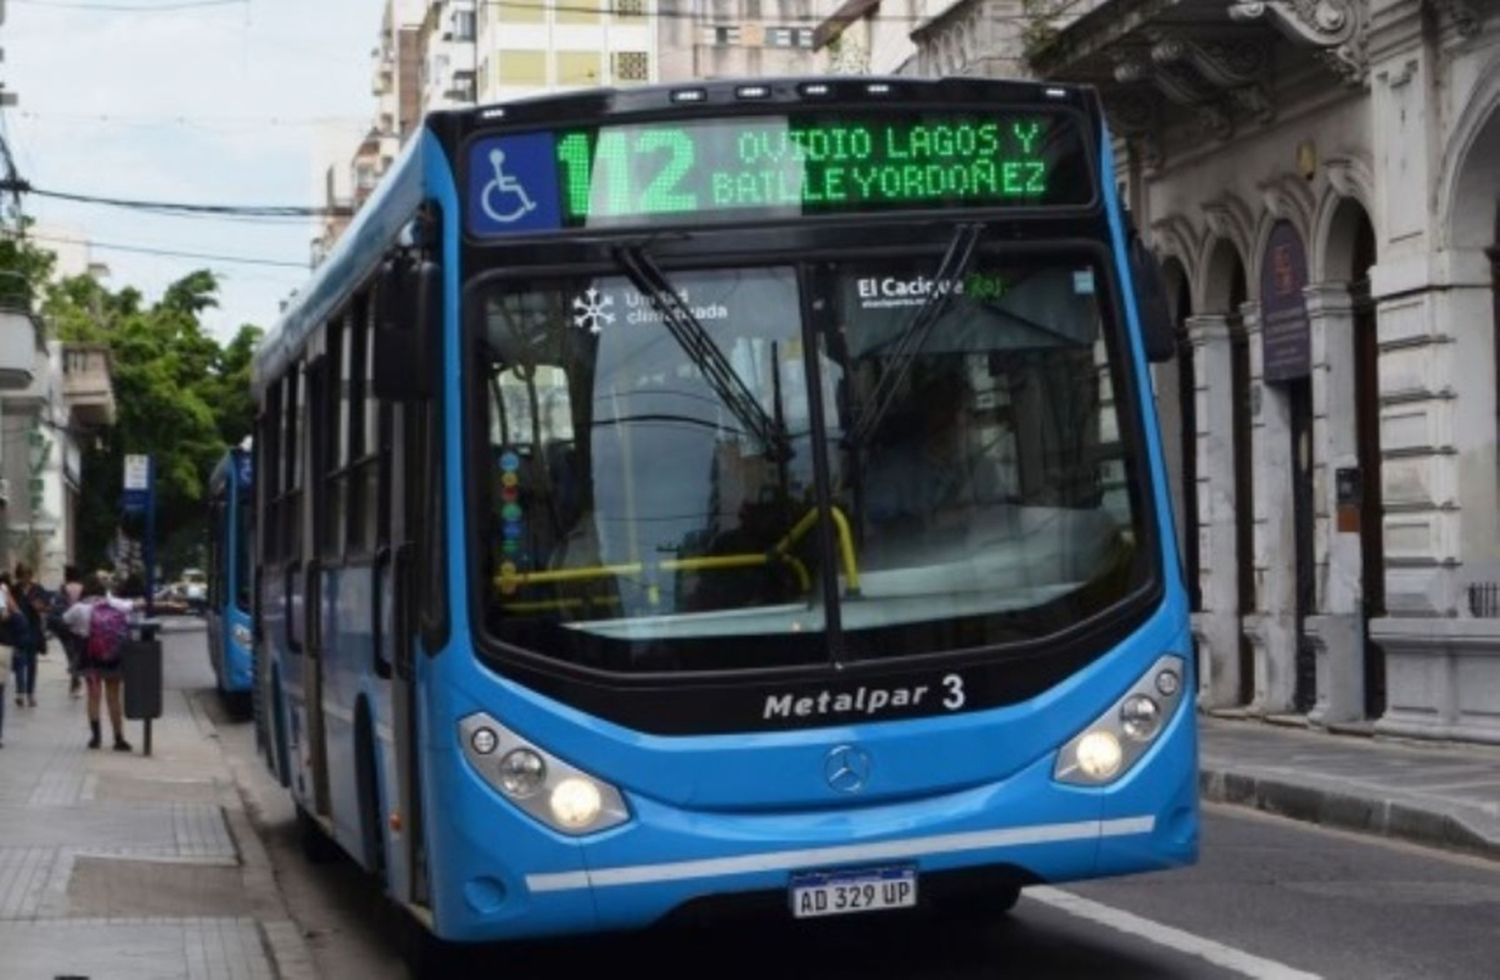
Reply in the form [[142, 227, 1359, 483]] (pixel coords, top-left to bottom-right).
[[1304, 282, 1379, 725]]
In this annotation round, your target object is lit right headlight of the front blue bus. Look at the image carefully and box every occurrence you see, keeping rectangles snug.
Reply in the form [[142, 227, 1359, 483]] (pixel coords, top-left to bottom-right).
[[1052, 654, 1185, 786]]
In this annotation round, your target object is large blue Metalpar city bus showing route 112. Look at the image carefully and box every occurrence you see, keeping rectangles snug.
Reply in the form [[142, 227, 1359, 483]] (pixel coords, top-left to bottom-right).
[[254, 78, 1199, 942]]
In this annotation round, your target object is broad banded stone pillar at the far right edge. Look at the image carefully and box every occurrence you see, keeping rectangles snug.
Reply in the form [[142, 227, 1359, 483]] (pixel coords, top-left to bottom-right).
[[1371, 249, 1500, 741]]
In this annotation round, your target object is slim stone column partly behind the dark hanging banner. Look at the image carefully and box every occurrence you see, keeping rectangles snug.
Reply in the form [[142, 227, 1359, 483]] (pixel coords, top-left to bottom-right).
[[1241, 303, 1298, 714]]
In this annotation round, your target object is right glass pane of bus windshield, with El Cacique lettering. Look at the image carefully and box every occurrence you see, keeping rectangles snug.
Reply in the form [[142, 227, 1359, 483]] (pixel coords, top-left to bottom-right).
[[824, 258, 1136, 656]]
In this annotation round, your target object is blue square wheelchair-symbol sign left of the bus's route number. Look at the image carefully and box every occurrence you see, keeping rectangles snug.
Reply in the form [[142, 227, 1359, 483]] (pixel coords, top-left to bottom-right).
[[468, 132, 563, 236]]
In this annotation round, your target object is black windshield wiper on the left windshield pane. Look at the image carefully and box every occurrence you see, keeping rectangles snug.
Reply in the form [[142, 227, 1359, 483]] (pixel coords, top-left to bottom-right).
[[615, 246, 792, 461]]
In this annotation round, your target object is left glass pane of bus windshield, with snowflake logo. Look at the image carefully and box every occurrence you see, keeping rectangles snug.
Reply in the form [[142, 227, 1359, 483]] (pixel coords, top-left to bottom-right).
[[485, 269, 824, 662]]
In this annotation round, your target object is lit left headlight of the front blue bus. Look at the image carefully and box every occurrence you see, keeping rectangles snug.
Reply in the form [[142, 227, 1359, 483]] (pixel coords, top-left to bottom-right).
[[459, 711, 630, 836]]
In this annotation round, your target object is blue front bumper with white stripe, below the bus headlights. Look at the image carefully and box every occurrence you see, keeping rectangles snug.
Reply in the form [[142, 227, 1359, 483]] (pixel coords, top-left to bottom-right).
[[434, 701, 1199, 942]]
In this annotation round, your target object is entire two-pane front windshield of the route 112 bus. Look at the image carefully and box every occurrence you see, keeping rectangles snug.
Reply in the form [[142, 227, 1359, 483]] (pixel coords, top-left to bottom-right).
[[473, 249, 1149, 671]]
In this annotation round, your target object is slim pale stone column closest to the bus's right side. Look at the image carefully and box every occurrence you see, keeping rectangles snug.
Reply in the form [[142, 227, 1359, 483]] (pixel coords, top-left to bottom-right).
[[1185, 317, 1239, 708]]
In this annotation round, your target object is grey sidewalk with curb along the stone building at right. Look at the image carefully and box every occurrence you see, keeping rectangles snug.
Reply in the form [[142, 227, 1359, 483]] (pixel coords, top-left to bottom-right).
[[1199, 717, 1500, 860]]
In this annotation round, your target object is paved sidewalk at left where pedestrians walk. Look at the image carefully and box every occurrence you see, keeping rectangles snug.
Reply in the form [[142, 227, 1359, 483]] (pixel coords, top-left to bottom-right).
[[0, 624, 312, 980]]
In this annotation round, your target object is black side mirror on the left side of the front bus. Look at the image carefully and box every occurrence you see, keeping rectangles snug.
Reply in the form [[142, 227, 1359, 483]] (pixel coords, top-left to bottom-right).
[[371, 261, 443, 402]]
